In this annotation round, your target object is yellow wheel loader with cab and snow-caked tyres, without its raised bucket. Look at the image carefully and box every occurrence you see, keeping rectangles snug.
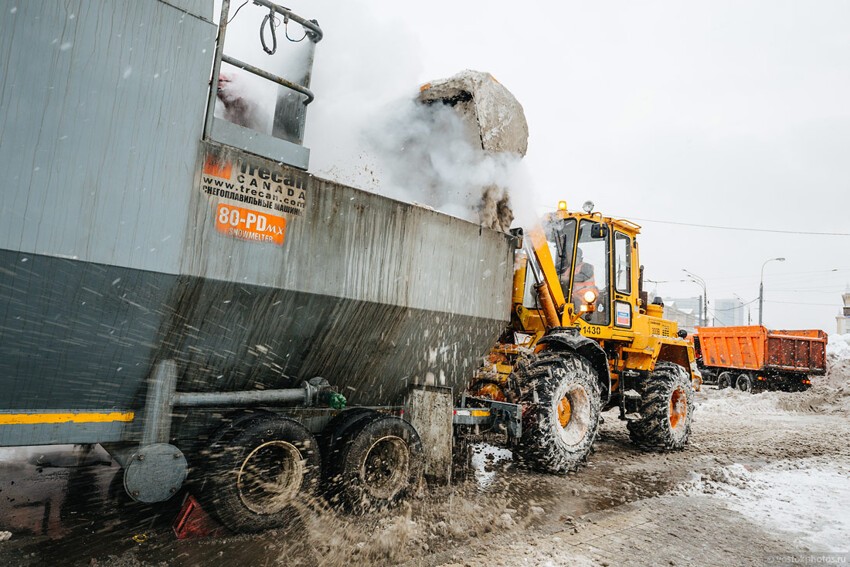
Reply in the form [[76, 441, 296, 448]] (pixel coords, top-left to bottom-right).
[[469, 201, 701, 473]]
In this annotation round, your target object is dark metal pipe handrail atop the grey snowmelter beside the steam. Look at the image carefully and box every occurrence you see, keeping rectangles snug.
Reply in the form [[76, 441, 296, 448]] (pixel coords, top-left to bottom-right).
[[204, 0, 324, 139]]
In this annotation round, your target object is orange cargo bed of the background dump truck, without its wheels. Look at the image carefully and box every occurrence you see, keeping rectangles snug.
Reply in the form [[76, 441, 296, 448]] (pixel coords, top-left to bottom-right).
[[697, 325, 827, 375]]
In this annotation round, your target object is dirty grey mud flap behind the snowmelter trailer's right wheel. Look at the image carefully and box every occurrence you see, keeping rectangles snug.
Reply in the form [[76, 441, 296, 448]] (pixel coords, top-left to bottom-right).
[[404, 386, 454, 484]]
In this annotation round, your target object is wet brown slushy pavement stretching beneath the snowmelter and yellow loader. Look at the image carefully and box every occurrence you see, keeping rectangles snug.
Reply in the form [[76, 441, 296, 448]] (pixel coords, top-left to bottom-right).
[[0, 391, 850, 567]]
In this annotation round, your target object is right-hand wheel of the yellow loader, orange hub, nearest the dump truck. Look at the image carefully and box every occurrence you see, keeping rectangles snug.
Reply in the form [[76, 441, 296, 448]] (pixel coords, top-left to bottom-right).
[[627, 362, 694, 451]]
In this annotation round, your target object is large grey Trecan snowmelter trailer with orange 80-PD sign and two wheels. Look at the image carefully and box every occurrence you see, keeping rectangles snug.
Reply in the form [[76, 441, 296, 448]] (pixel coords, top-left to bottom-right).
[[0, 0, 514, 530]]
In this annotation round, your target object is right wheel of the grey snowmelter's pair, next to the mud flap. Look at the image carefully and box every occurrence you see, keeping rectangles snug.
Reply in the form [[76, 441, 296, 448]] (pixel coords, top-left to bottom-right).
[[329, 415, 425, 514]]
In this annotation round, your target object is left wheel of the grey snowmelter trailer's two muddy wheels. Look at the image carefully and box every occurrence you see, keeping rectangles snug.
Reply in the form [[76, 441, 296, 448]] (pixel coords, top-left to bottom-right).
[[202, 415, 319, 532]]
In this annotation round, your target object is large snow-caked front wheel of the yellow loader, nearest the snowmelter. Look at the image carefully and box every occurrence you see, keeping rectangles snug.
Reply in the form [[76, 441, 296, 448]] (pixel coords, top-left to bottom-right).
[[514, 352, 602, 474]]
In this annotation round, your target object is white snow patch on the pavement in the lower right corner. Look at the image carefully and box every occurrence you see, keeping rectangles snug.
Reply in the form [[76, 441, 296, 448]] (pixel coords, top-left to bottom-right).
[[680, 458, 850, 552]]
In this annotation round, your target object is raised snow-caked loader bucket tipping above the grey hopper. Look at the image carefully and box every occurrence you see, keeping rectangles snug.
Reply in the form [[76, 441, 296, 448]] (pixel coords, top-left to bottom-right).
[[419, 70, 528, 157]]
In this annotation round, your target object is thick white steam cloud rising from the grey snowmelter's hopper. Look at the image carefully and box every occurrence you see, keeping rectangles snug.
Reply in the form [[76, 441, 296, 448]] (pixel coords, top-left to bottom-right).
[[210, 0, 534, 230]]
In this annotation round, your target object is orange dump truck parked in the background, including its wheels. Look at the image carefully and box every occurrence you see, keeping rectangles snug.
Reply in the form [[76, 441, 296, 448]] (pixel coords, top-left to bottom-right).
[[694, 325, 826, 392]]
